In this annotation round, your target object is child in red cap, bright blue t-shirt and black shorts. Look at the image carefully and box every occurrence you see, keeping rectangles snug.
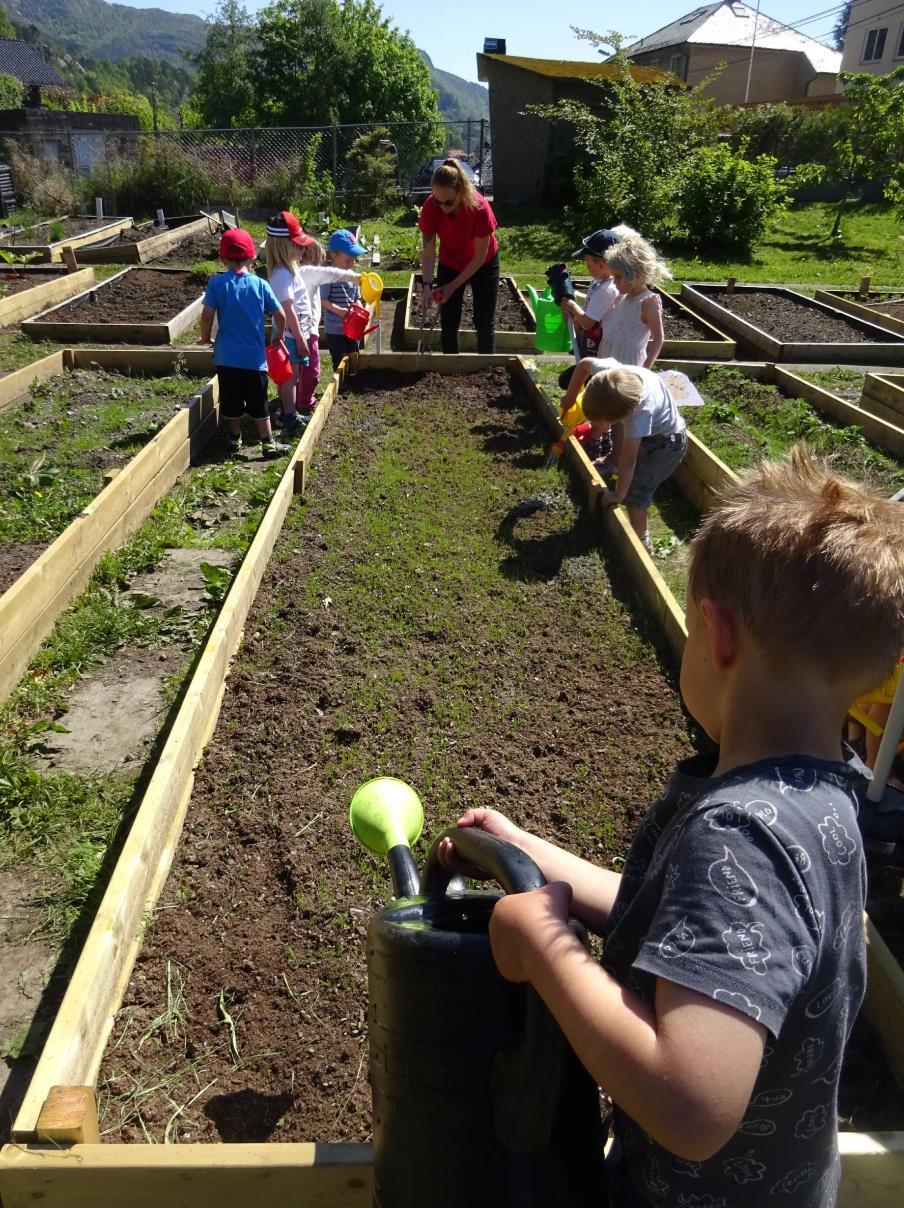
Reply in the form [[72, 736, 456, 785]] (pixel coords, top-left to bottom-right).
[[201, 228, 288, 458]]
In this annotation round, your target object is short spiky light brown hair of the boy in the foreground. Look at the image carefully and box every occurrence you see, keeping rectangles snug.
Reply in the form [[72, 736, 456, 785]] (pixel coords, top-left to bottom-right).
[[688, 446, 904, 692]]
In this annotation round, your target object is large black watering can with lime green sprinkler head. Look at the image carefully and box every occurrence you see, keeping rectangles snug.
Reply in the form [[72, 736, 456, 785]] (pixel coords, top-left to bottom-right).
[[352, 778, 605, 1208]]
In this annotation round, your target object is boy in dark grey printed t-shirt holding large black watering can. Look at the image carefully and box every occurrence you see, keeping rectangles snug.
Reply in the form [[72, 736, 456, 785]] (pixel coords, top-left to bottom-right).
[[440, 449, 904, 1208]]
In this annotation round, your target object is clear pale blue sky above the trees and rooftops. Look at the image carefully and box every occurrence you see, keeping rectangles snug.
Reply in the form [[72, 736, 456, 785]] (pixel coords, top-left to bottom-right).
[[118, 0, 842, 80]]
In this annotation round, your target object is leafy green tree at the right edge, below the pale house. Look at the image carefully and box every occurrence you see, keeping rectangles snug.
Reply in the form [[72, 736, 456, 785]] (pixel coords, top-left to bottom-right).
[[796, 66, 904, 238]]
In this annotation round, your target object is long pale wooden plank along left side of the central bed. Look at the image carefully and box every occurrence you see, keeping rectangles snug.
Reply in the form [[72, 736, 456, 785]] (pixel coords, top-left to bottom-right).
[[12, 382, 336, 1142]]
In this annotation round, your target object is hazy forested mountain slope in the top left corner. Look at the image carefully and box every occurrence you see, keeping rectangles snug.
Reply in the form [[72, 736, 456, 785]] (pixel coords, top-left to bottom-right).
[[6, 0, 207, 66]]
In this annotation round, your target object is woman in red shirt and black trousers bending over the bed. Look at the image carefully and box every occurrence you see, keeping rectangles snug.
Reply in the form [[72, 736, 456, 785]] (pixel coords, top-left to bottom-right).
[[418, 159, 499, 353]]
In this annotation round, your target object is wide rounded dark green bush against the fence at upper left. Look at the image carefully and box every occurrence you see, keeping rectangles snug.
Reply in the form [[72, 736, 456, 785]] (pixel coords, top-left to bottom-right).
[[82, 147, 222, 216]]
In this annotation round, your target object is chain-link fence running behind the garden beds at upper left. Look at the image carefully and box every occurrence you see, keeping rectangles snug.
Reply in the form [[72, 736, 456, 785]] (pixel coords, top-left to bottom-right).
[[0, 115, 493, 194]]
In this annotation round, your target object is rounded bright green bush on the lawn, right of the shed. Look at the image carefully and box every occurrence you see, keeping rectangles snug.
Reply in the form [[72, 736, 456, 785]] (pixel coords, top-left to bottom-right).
[[676, 143, 784, 251]]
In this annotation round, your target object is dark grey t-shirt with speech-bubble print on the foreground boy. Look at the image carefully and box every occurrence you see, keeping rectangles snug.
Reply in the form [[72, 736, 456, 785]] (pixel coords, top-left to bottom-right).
[[603, 754, 867, 1208]]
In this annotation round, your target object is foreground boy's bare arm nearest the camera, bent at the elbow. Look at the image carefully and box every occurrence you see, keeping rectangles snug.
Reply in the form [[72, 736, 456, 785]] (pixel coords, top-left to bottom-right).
[[489, 882, 766, 1161]]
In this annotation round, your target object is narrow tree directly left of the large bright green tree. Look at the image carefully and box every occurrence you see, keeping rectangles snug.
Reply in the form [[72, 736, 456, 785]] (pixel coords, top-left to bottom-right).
[[191, 0, 257, 129]]
